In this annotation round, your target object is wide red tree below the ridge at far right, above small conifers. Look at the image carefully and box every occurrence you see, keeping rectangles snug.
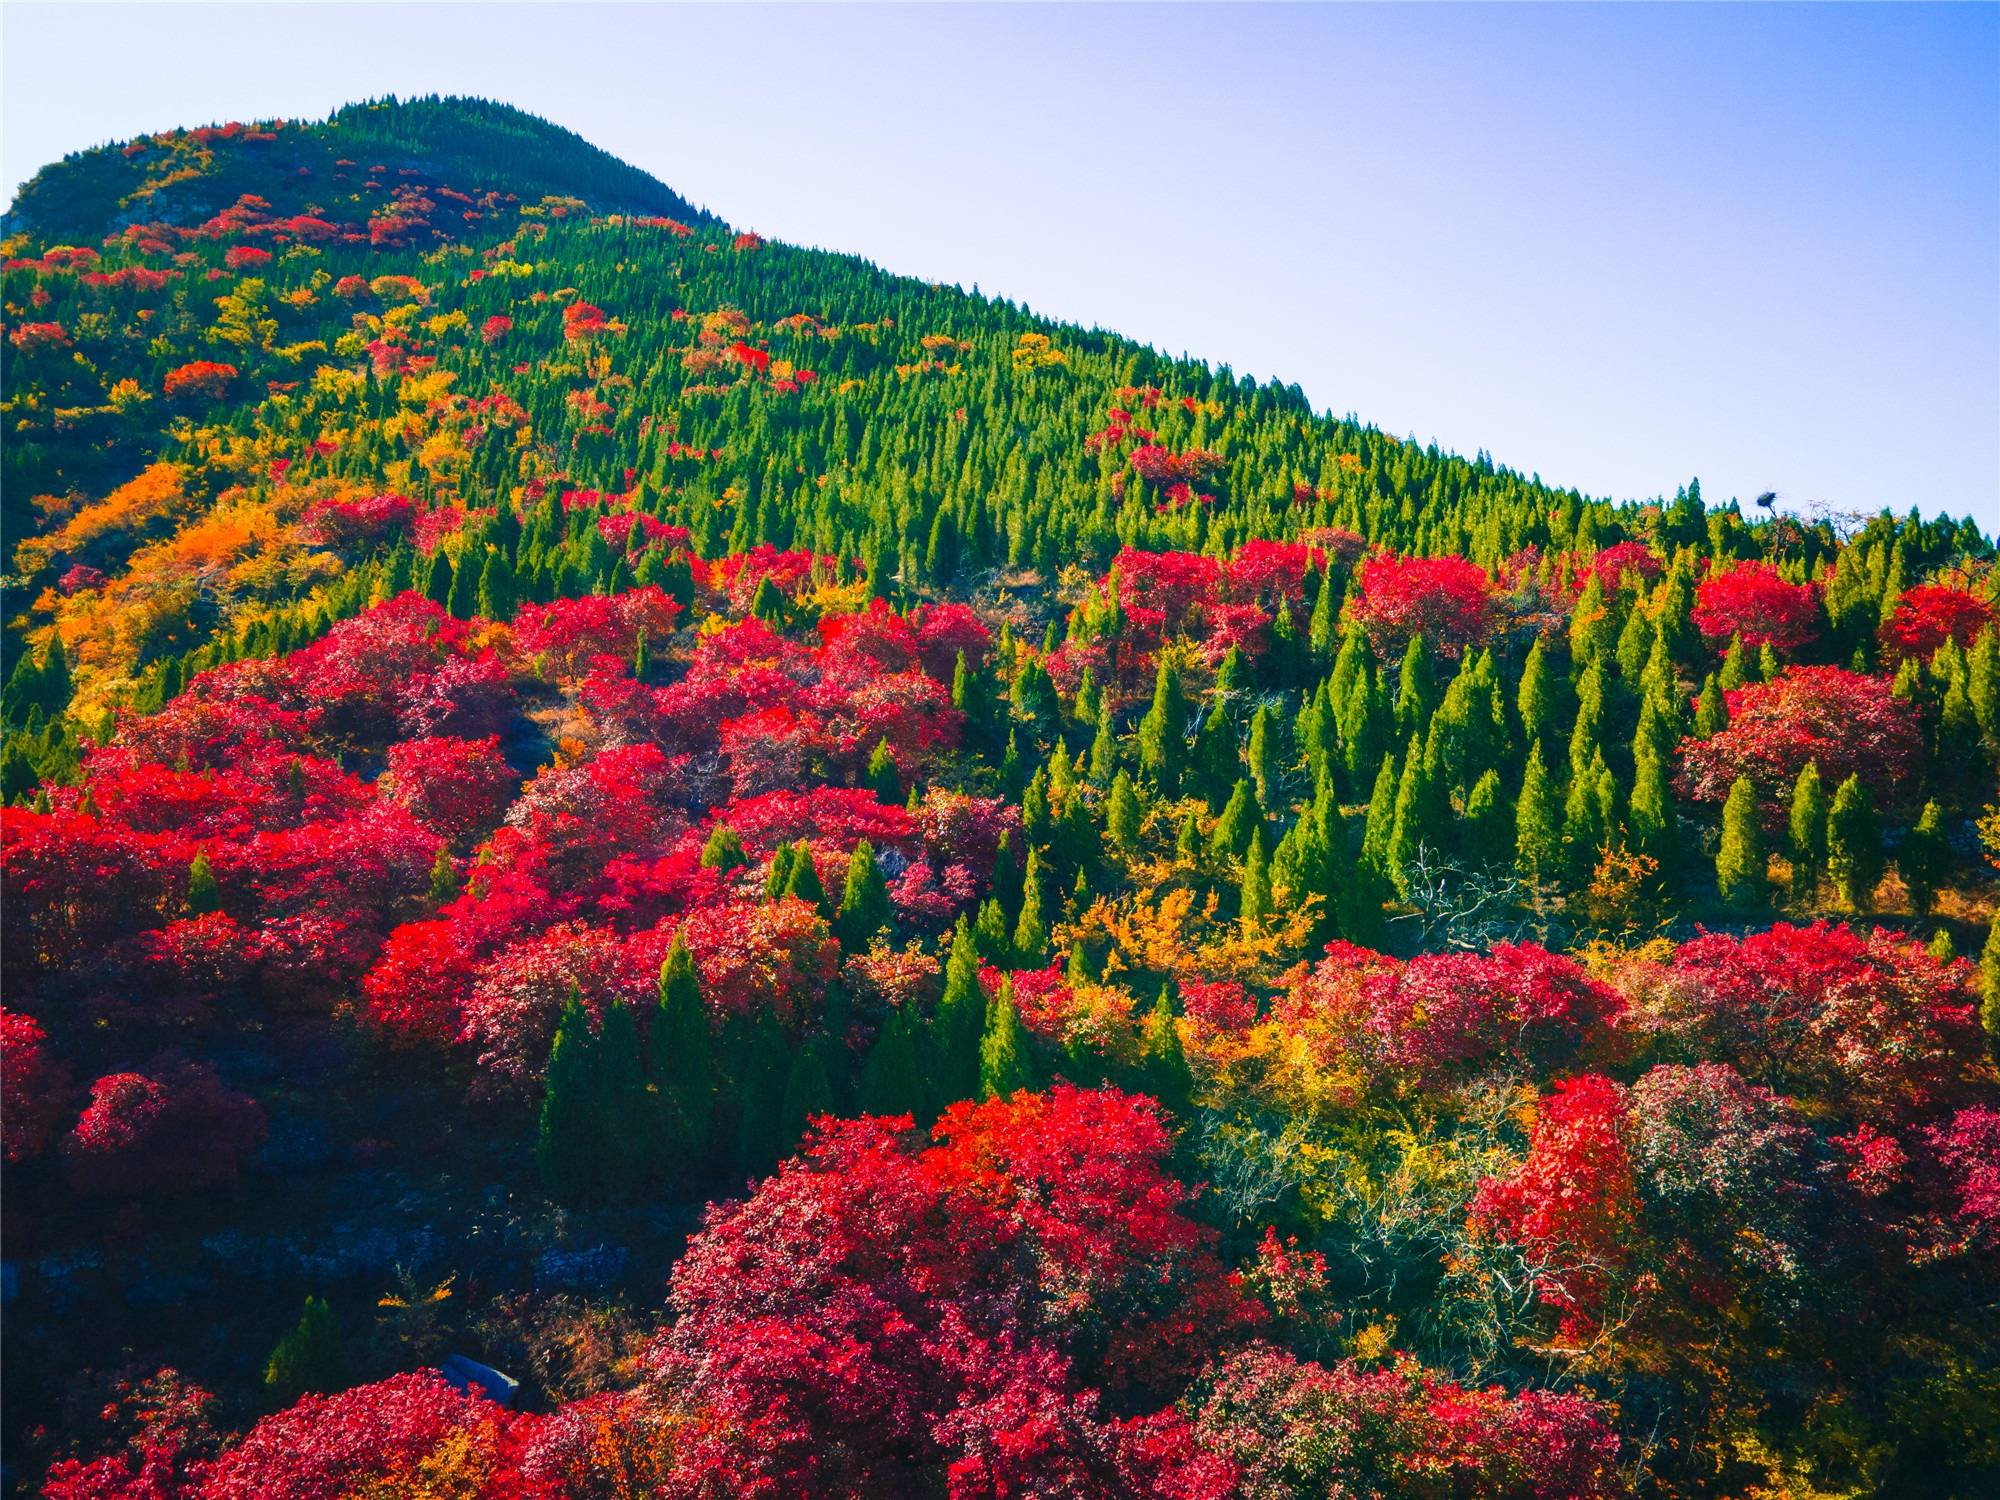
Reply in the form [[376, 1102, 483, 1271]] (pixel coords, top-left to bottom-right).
[[1680, 666, 1924, 826]]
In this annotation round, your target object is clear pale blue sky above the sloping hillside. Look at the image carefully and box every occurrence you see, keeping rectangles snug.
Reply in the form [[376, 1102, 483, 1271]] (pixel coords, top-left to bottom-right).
[[0, 4, 2000, 528]]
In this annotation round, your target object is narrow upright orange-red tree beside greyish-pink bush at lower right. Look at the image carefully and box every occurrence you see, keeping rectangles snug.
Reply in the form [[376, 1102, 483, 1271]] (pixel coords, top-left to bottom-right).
[[1472, 1074, 1638, 1338]]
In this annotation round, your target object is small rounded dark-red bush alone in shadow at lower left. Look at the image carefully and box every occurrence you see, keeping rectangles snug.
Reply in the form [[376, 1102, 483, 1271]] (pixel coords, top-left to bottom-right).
[[62, 1058, 264, 1196]]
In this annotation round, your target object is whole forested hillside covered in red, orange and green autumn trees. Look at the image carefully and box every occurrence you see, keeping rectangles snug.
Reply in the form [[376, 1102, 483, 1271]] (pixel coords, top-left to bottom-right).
[[0, 100, 2000, 1500]]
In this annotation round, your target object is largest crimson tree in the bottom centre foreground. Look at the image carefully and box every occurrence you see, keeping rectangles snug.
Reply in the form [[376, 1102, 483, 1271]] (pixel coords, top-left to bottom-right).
[[652, 1088, 1250, 1496]]
